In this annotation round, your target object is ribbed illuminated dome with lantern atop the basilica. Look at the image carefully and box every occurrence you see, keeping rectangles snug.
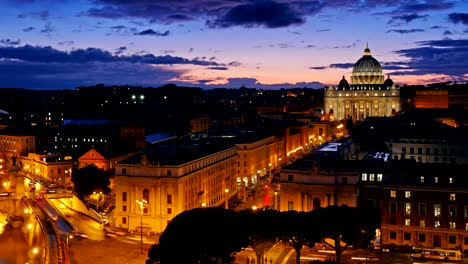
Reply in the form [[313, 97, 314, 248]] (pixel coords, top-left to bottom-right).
[[351, 45, 384, 86]]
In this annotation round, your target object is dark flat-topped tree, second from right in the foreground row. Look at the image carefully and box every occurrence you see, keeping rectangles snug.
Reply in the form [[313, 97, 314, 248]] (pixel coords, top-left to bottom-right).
[[278, 211, 321, 264]]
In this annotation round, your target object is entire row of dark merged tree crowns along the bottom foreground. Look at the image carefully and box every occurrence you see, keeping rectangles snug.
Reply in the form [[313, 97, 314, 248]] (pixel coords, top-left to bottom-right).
[[147, 206, 369, 264]]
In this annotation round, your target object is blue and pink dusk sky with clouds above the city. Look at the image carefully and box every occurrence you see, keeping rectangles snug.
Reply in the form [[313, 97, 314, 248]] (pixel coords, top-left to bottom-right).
[[0, 0, 468, 89]]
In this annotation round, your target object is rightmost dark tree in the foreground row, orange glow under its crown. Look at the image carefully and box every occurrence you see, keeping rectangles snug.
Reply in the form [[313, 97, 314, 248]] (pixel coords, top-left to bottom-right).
[[312, 205, 361, 263]]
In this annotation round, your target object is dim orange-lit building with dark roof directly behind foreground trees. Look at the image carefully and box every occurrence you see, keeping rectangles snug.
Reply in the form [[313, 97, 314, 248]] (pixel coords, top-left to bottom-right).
[[275, 151, 359, 212]]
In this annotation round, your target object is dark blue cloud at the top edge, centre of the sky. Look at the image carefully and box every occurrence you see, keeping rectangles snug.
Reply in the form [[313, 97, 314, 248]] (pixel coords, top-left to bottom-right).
[[207, 0, 305, 28]]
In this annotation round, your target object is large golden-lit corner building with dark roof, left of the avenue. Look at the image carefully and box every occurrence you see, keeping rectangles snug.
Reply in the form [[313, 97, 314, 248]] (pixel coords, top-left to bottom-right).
[[115, 137, 237, 232]]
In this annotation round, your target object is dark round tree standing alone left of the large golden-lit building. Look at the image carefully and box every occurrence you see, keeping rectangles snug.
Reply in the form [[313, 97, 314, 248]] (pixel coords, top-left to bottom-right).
[[71, 165, 110, 199]]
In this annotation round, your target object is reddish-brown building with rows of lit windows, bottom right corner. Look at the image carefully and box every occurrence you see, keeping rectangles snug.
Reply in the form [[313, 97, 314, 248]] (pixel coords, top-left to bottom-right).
[[359, 160, 468, 250]]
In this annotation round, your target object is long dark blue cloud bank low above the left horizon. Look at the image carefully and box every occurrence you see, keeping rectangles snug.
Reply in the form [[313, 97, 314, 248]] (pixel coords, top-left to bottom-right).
[[0, 61, 185, 89]]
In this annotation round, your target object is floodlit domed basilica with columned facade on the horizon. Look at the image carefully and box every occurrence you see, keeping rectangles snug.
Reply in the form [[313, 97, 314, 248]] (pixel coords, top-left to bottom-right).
[[324, 46, 400, 121]]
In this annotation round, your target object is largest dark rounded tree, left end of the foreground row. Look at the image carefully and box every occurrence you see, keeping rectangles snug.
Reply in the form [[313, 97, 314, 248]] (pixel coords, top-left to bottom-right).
[[153, 207, 248, 264]]
